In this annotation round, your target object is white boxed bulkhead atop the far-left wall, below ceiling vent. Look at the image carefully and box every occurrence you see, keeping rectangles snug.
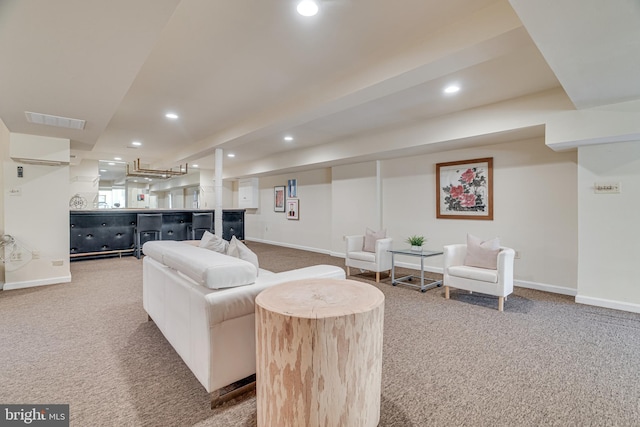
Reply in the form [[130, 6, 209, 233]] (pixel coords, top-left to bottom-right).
[[9, 133, 70, 166]]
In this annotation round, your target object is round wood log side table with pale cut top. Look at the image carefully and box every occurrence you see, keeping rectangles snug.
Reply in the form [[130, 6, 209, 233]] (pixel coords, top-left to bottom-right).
[[256, 279, 384, 427]]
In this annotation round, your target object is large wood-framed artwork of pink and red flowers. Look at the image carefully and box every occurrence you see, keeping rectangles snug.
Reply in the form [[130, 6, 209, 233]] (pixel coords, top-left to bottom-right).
[[436, 157, 493, 220]]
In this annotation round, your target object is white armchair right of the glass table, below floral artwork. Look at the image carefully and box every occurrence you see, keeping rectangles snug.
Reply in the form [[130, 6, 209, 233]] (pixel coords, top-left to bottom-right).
[[443, 244, 515, 311]]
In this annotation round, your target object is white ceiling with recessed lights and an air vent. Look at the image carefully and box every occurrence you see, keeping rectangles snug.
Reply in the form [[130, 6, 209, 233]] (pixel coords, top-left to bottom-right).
[[0, 0, 640, 177]]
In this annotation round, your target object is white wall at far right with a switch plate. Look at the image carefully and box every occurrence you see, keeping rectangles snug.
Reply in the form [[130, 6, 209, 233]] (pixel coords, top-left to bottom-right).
[[576, 141, 640, 312]]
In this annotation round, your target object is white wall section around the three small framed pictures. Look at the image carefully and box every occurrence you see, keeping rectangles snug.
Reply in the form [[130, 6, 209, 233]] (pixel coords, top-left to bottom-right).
[[245, 168, 332, 253]]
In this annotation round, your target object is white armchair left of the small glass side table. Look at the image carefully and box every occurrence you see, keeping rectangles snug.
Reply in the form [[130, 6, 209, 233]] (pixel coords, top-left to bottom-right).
[[345, 235, 393, 282]]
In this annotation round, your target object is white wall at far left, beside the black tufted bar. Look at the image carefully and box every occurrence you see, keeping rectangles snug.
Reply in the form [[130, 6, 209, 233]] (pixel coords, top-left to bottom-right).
[[3, 134, 71, 290]]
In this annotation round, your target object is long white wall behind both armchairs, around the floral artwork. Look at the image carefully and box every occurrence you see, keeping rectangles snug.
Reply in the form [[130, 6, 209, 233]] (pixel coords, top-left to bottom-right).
[[245, 138, 578, 295]]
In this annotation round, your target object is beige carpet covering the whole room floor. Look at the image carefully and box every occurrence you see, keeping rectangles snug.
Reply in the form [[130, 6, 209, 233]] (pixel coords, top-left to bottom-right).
[[0, 242, 640, 427]]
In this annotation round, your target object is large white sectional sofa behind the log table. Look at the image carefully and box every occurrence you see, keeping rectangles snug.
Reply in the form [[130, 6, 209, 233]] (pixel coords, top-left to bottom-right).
[[143, 241, 345, 405]]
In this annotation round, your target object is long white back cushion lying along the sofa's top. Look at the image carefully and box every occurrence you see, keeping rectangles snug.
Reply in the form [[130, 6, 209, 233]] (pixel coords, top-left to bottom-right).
[[143, 240, 258, 289]]
